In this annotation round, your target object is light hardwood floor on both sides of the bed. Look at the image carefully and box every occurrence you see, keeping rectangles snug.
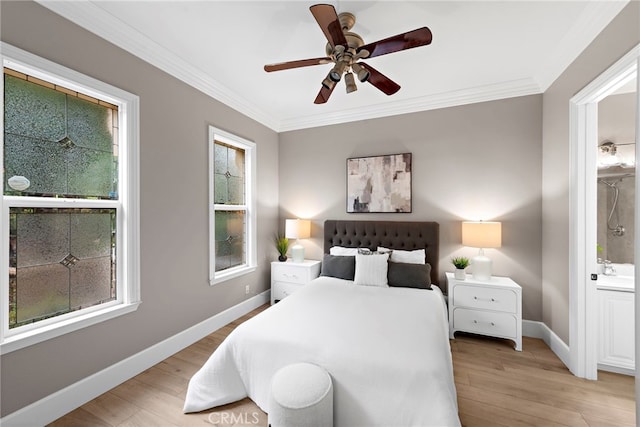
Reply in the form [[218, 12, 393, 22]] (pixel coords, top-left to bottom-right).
[[50, 305, 635, 427]]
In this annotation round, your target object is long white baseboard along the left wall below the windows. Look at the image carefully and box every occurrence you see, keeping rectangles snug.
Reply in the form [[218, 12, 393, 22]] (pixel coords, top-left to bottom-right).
[[0, 291, 271, 427]]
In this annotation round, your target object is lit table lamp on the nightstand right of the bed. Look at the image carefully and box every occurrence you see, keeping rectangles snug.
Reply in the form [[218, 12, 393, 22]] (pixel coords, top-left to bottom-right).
[[462, 221, 502, 280]]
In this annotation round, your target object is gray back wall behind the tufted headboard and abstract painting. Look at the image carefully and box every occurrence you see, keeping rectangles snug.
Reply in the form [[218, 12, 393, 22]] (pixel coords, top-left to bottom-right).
[[280, 93, 542, 320]]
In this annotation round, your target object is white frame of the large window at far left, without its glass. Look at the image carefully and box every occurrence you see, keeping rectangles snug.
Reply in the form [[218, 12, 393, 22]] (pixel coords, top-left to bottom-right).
[[0, 42, 141, 354]]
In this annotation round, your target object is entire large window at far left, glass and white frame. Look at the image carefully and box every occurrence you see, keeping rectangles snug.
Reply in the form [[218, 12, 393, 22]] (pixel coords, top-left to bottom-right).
[[0, 43, 139, 353]]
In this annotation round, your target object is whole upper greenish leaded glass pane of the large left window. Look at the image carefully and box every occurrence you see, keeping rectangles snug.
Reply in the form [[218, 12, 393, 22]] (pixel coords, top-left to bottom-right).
[[4, 75, 118, 199]]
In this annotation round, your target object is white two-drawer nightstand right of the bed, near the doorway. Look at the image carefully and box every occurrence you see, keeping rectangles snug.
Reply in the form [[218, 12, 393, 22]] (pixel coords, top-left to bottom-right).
[[446, 272, 522, 351]]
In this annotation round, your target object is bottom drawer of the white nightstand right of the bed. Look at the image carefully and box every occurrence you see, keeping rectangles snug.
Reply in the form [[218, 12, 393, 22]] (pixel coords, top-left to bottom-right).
[[453, 308, 518, 337]]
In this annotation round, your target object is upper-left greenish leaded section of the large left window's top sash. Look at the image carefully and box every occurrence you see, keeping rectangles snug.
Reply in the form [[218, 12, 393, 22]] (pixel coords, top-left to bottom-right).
[[4, 74, 66, 141]]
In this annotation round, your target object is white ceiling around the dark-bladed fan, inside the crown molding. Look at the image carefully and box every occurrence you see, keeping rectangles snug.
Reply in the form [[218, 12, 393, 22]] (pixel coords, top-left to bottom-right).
[[40, 0, 627, 132]]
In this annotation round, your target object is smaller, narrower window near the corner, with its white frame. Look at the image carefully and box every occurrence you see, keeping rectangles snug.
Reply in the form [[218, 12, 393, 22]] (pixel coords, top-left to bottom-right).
[[209, 127, 256, 284]]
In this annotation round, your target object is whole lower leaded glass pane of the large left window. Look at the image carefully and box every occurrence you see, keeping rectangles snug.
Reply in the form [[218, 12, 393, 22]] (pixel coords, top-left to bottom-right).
[[9, 208, 116, 328]]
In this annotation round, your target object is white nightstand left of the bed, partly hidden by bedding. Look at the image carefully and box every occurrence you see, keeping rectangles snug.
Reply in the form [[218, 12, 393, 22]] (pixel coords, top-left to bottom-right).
[[271, 259, 321, 304]]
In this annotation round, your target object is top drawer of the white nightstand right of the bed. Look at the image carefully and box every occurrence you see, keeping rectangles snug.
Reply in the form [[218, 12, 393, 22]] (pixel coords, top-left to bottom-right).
[[453, 285, 518, 313]]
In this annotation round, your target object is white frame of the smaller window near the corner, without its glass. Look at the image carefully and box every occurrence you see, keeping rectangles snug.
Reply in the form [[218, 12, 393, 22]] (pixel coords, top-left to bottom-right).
[[208, 125, 258, 286]]
